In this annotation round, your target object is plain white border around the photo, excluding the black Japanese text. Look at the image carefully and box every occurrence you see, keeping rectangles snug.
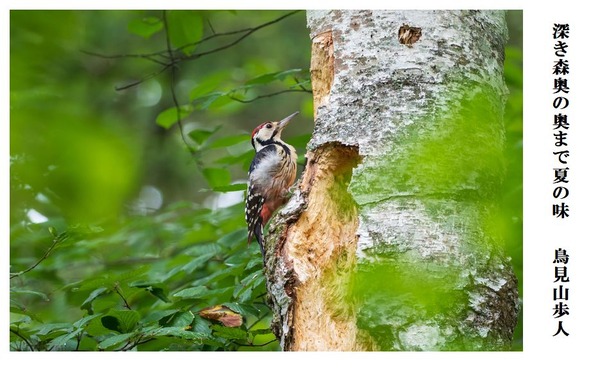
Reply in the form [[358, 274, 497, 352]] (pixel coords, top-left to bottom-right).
[[0, 0, 600, 389]]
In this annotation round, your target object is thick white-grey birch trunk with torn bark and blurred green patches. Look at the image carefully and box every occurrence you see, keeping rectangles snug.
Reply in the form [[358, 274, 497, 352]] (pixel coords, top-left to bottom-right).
[[265, 11, 518, 350]]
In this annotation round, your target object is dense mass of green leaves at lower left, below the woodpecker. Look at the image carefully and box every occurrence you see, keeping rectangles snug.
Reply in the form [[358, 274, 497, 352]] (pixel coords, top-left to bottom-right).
[[10, 203, 276, 351]]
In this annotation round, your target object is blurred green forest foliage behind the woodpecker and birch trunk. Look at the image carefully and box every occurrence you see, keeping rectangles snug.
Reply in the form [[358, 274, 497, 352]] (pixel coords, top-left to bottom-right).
[[10, 11, 522, 350]]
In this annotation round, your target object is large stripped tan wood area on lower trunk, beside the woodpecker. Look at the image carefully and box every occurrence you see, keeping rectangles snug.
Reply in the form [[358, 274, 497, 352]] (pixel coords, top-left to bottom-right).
[[265, 143, 360, 351]]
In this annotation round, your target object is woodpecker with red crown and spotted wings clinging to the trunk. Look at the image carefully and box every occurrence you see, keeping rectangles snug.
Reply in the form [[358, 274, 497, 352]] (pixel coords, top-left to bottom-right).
[[245, 111, 298, 257]]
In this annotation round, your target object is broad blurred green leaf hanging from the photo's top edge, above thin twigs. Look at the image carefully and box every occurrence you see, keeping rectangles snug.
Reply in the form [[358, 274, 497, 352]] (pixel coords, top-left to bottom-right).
[[167, 10, 203, 56]]
